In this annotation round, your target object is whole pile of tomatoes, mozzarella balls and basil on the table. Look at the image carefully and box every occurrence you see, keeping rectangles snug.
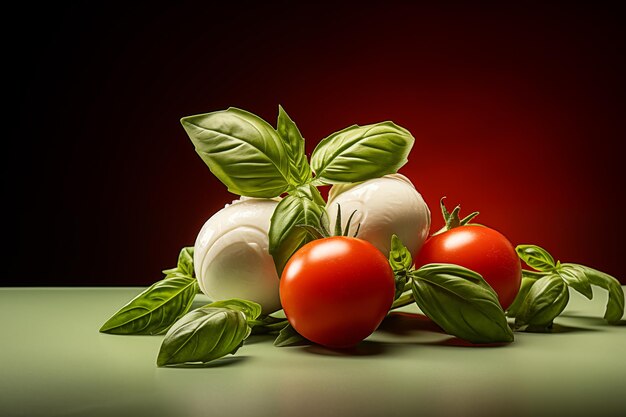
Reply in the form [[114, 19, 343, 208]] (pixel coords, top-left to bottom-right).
[[100, 107, 624, 366]]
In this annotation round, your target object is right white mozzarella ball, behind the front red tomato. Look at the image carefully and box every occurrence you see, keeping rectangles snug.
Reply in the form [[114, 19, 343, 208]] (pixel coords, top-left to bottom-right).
[[326, 174, 430, 256]]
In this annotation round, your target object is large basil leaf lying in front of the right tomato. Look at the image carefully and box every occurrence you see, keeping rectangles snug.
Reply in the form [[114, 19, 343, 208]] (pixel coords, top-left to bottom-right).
[[412, 264, 513, 343]]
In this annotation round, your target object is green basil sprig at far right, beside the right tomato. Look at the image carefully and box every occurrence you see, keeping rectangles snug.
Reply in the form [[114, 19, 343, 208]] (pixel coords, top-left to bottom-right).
[[507, 245, 624, 331]]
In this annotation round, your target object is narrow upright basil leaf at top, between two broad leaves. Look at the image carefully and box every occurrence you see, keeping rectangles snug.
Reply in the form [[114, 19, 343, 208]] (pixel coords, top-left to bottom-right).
[[276, 106, 311, 186]]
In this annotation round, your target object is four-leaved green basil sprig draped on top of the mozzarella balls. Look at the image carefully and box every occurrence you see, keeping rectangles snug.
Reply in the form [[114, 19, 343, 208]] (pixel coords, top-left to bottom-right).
[[181, 106, 415, 274]]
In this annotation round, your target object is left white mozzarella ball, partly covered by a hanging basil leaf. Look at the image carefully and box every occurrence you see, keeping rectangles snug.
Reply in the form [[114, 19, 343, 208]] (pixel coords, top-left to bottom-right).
[[194, 198, 280, 313]]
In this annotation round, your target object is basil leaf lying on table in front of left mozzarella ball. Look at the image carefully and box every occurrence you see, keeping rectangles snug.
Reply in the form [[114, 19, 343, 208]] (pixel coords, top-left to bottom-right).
[[157, 307, 250, 366]]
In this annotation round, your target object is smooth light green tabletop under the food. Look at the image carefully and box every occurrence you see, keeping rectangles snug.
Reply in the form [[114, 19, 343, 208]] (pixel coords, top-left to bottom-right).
[[0, 287, 626, 417]]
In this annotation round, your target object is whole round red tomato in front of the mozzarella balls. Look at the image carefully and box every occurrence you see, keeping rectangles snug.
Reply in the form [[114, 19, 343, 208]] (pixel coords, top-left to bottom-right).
[[280, 236, 395, 348]]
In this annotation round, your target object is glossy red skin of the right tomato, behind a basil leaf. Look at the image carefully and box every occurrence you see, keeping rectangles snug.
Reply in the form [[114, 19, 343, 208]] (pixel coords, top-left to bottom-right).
[[415, 225, 522, 310]]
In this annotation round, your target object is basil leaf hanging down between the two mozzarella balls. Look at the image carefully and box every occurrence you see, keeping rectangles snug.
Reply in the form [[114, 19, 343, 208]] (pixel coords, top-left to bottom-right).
[[268, 187, 324, 277]]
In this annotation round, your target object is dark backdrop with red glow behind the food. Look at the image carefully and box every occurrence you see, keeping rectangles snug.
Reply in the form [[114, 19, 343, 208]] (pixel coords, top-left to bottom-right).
[[6, 2, 626, 286]]
